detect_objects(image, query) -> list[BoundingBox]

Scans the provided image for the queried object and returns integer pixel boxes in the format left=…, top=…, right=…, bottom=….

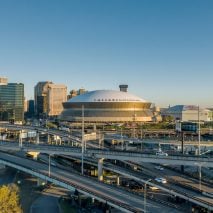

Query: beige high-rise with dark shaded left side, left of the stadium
left=35, top=81, right=67, bottom=117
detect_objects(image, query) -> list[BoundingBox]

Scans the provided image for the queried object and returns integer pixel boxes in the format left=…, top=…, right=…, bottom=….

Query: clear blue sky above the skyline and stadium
left=0, top=0, right=213, bottom=107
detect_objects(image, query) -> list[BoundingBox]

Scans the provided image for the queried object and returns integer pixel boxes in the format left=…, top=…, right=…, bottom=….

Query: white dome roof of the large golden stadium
left=68, top=90, right=147, bottom=103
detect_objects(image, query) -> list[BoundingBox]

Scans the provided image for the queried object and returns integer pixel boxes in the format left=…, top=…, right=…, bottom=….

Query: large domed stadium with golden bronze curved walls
left=59, top=90, right=152, bottom=123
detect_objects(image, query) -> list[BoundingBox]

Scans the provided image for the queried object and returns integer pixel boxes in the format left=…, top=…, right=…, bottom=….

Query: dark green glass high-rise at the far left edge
left=0, top=78, right=24, bottom=123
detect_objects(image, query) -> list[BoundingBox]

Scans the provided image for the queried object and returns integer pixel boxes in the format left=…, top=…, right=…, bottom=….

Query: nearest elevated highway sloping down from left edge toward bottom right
left=0, top=152, right=181, bottom=213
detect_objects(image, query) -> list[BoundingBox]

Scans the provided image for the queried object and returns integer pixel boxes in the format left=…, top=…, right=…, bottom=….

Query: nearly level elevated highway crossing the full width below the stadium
left=0, top=142, right=213, bottom=167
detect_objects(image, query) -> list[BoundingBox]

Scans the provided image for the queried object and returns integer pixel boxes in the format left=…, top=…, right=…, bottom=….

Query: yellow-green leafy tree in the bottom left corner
left=0, top=184, right=23, bottom=213
